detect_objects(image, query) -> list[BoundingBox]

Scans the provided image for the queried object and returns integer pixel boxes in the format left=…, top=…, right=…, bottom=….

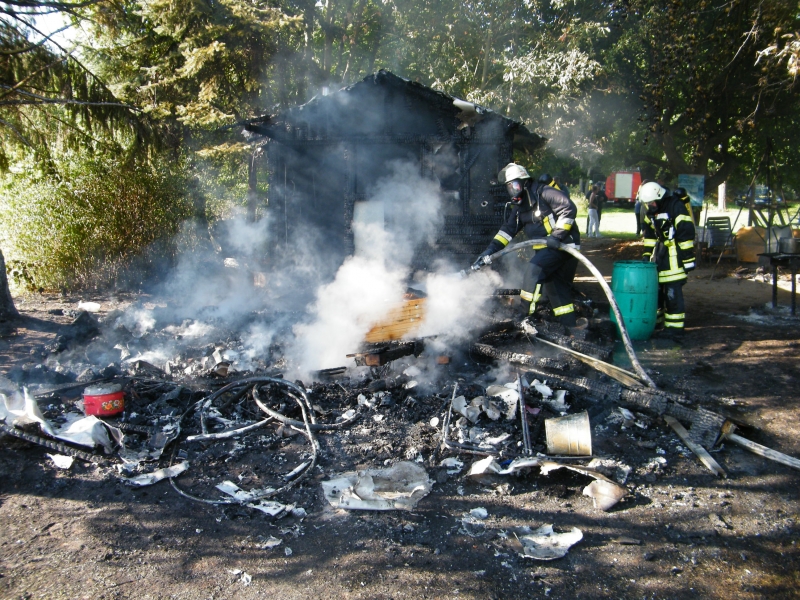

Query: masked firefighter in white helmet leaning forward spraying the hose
left=474, top=163, right=580, bottom=327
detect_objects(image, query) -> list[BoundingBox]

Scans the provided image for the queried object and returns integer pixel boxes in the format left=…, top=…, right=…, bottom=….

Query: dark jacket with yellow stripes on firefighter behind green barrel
left=642, top=195, right=695, bottom=283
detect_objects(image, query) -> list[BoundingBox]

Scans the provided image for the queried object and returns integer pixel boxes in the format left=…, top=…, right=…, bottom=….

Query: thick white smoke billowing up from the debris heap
left=104, top=162, right=506, bottom=379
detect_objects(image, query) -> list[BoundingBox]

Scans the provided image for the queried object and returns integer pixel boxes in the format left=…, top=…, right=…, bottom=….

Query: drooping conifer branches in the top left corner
left=0, top=0, right=156, bottom=170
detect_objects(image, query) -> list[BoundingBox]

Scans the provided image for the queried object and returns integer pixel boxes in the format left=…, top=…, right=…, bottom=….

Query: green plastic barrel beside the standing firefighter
left=611, top=260, right=658, bottom=340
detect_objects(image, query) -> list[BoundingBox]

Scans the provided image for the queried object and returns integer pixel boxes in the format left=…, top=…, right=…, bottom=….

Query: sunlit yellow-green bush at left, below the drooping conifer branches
left=0, top=154, right=192, bottom=289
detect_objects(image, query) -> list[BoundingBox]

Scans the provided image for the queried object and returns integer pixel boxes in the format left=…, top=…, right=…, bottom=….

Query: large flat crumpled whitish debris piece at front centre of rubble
left=322, top=461, right=432, bottom=510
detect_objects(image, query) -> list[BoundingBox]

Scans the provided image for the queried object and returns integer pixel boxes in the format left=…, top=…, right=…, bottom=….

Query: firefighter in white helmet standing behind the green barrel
left=638, top=181, right=695, bottom=338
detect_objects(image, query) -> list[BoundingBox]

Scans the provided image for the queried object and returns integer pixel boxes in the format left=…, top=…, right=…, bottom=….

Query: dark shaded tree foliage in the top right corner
left=605, top=0, right=798, bottom=188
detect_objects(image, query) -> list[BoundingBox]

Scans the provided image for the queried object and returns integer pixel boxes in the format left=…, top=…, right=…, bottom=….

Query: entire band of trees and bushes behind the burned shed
left=0, top=0, right=800, bottom=298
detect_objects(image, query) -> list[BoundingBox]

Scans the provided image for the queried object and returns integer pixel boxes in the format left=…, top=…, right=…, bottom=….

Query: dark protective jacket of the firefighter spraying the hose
left=487, top=181, right=581, bottom=254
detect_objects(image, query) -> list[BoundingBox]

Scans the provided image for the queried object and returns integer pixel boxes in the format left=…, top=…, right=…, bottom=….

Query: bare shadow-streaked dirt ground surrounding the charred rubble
left=0, top=239, right=800, bottom=600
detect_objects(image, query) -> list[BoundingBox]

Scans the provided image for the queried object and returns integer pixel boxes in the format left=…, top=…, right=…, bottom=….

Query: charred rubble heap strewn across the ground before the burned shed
left=0, top=286, right=791, bottom=580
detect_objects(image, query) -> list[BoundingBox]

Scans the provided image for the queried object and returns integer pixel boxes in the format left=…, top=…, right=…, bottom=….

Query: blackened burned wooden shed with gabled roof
left=246, top=70, right=544, bottom=269
